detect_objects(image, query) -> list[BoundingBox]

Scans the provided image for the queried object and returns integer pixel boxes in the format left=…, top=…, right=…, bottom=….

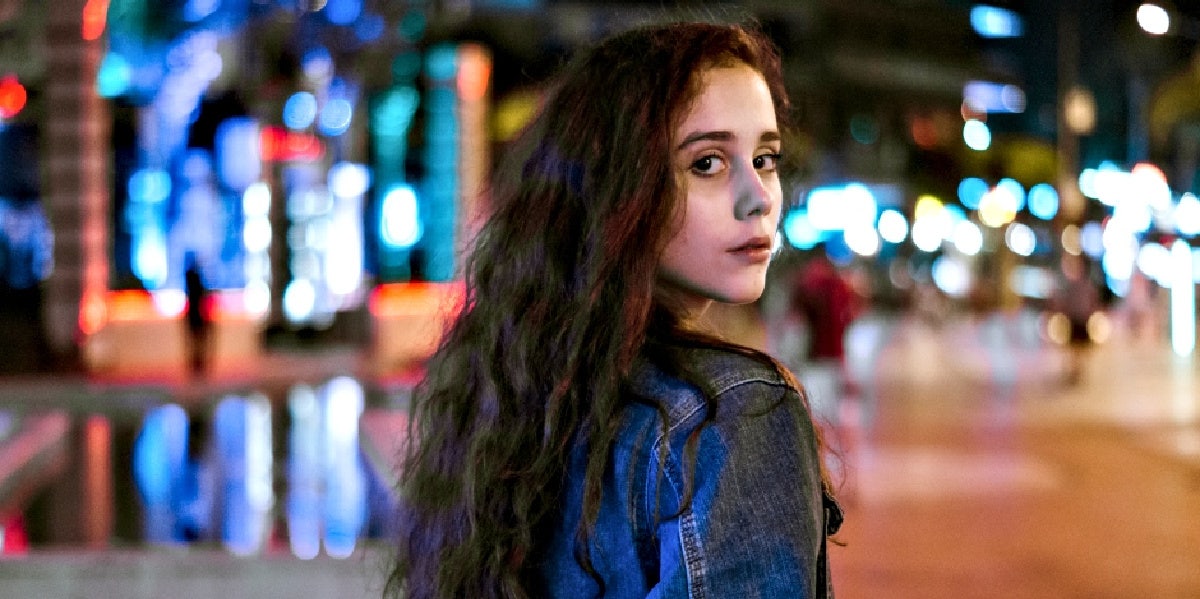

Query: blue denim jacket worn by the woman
left=538, top=348, right=841, bottom=599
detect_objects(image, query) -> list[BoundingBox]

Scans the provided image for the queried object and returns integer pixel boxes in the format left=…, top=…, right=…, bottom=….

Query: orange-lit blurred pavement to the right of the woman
left=830, top=312, right=1200, bottom=599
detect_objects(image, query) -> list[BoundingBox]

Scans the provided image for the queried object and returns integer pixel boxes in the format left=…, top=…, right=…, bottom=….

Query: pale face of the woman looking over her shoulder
left=658, top=65, right=782, bottom=312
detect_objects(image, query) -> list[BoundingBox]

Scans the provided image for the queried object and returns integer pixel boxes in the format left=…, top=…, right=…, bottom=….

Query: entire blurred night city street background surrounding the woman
left=0, top=0, right=1200, bottom=599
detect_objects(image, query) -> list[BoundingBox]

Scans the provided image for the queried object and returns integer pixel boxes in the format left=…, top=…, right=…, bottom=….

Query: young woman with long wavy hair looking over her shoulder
left=389, top=23, right=840, bottom=599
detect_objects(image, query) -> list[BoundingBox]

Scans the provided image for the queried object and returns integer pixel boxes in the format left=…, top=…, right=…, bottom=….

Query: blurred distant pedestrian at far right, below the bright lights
left=1052, top=253, right=1100, bottom=385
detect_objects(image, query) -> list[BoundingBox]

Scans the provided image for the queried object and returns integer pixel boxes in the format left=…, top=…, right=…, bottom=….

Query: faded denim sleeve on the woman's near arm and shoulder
left=647, top=382, right=829, bottom=598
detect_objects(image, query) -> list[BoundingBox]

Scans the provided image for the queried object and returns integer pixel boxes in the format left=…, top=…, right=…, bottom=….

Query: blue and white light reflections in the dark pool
left=133, top=377, right=386, bottom=559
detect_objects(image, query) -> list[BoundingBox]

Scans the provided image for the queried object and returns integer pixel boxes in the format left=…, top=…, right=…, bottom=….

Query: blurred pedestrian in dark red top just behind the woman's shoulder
left=792, top=245, right=862, bottom=423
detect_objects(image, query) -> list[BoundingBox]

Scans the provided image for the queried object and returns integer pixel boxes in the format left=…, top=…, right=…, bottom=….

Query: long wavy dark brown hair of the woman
left=388, top=18, right=825, bottom=599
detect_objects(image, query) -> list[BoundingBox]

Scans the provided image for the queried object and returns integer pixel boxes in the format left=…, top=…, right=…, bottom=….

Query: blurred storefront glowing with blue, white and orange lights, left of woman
left=0, top=0, right=491, bottom=372
